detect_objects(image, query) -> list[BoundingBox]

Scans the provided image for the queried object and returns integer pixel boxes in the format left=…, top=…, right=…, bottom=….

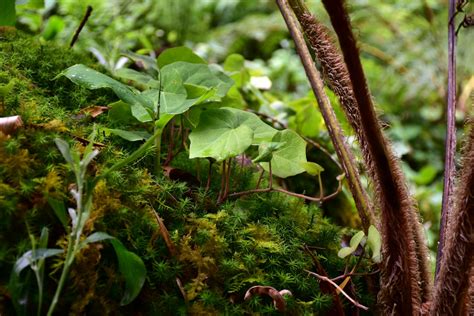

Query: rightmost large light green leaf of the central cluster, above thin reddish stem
left=259, top=130, right=307, bottom=178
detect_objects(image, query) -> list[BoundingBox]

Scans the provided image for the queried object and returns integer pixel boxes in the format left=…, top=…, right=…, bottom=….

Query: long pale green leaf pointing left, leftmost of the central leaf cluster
left=56, top=64, right=152, bottom=122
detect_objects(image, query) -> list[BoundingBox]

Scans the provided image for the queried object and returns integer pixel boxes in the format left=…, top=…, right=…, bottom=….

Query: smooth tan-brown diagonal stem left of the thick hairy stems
left=277, top=0, right=375, bottom=233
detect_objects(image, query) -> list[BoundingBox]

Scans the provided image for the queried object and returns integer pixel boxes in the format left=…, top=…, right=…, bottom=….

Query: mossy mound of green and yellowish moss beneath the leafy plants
left=0, top=29, right=373, bottom=315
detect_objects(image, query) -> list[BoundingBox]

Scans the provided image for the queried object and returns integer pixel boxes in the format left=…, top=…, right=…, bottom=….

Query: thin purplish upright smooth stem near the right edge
left=435, top=0, right=456, bottom=283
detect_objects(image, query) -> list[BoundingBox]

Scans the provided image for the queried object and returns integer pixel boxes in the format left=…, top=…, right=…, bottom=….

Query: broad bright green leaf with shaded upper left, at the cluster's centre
left=189, top=109, right=253, bottom=161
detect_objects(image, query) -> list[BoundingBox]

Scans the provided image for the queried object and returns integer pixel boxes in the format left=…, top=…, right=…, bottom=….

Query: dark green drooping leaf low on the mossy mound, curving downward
left=110, top=239, right=146, bottom=306
